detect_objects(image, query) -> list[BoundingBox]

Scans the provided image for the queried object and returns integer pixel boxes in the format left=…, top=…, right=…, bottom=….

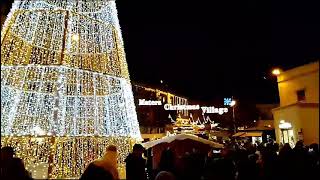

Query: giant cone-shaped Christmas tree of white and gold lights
left=1, top=0, right=141, bottom=178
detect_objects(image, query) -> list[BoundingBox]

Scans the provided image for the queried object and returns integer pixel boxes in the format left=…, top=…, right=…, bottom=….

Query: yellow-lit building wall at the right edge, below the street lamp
left=273, top=62, right=319, bottom=144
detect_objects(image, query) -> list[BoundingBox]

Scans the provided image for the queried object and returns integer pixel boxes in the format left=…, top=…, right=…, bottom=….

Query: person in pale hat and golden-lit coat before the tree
left=80, top=145, right=119, bottom=180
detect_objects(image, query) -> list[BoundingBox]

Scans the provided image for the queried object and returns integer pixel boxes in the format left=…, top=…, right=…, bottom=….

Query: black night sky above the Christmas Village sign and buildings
left=117, top=0, right=320, bottom=103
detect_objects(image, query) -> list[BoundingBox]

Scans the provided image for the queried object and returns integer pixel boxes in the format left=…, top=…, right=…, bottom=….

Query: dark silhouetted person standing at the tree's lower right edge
left=125, top=144, right=147, bottom=180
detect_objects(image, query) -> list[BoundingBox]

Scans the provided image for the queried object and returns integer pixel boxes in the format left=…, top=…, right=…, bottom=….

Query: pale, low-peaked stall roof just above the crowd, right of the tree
left=142, top=134, right=223, bottom=149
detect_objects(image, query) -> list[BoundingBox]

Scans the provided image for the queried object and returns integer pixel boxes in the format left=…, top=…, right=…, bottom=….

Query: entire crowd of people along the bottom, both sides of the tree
left=1, top=141, right=319, bottom=180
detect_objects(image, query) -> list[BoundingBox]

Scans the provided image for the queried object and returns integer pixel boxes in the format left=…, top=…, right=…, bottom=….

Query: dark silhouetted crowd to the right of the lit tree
left=127, top=141, right=320, bottom=180
